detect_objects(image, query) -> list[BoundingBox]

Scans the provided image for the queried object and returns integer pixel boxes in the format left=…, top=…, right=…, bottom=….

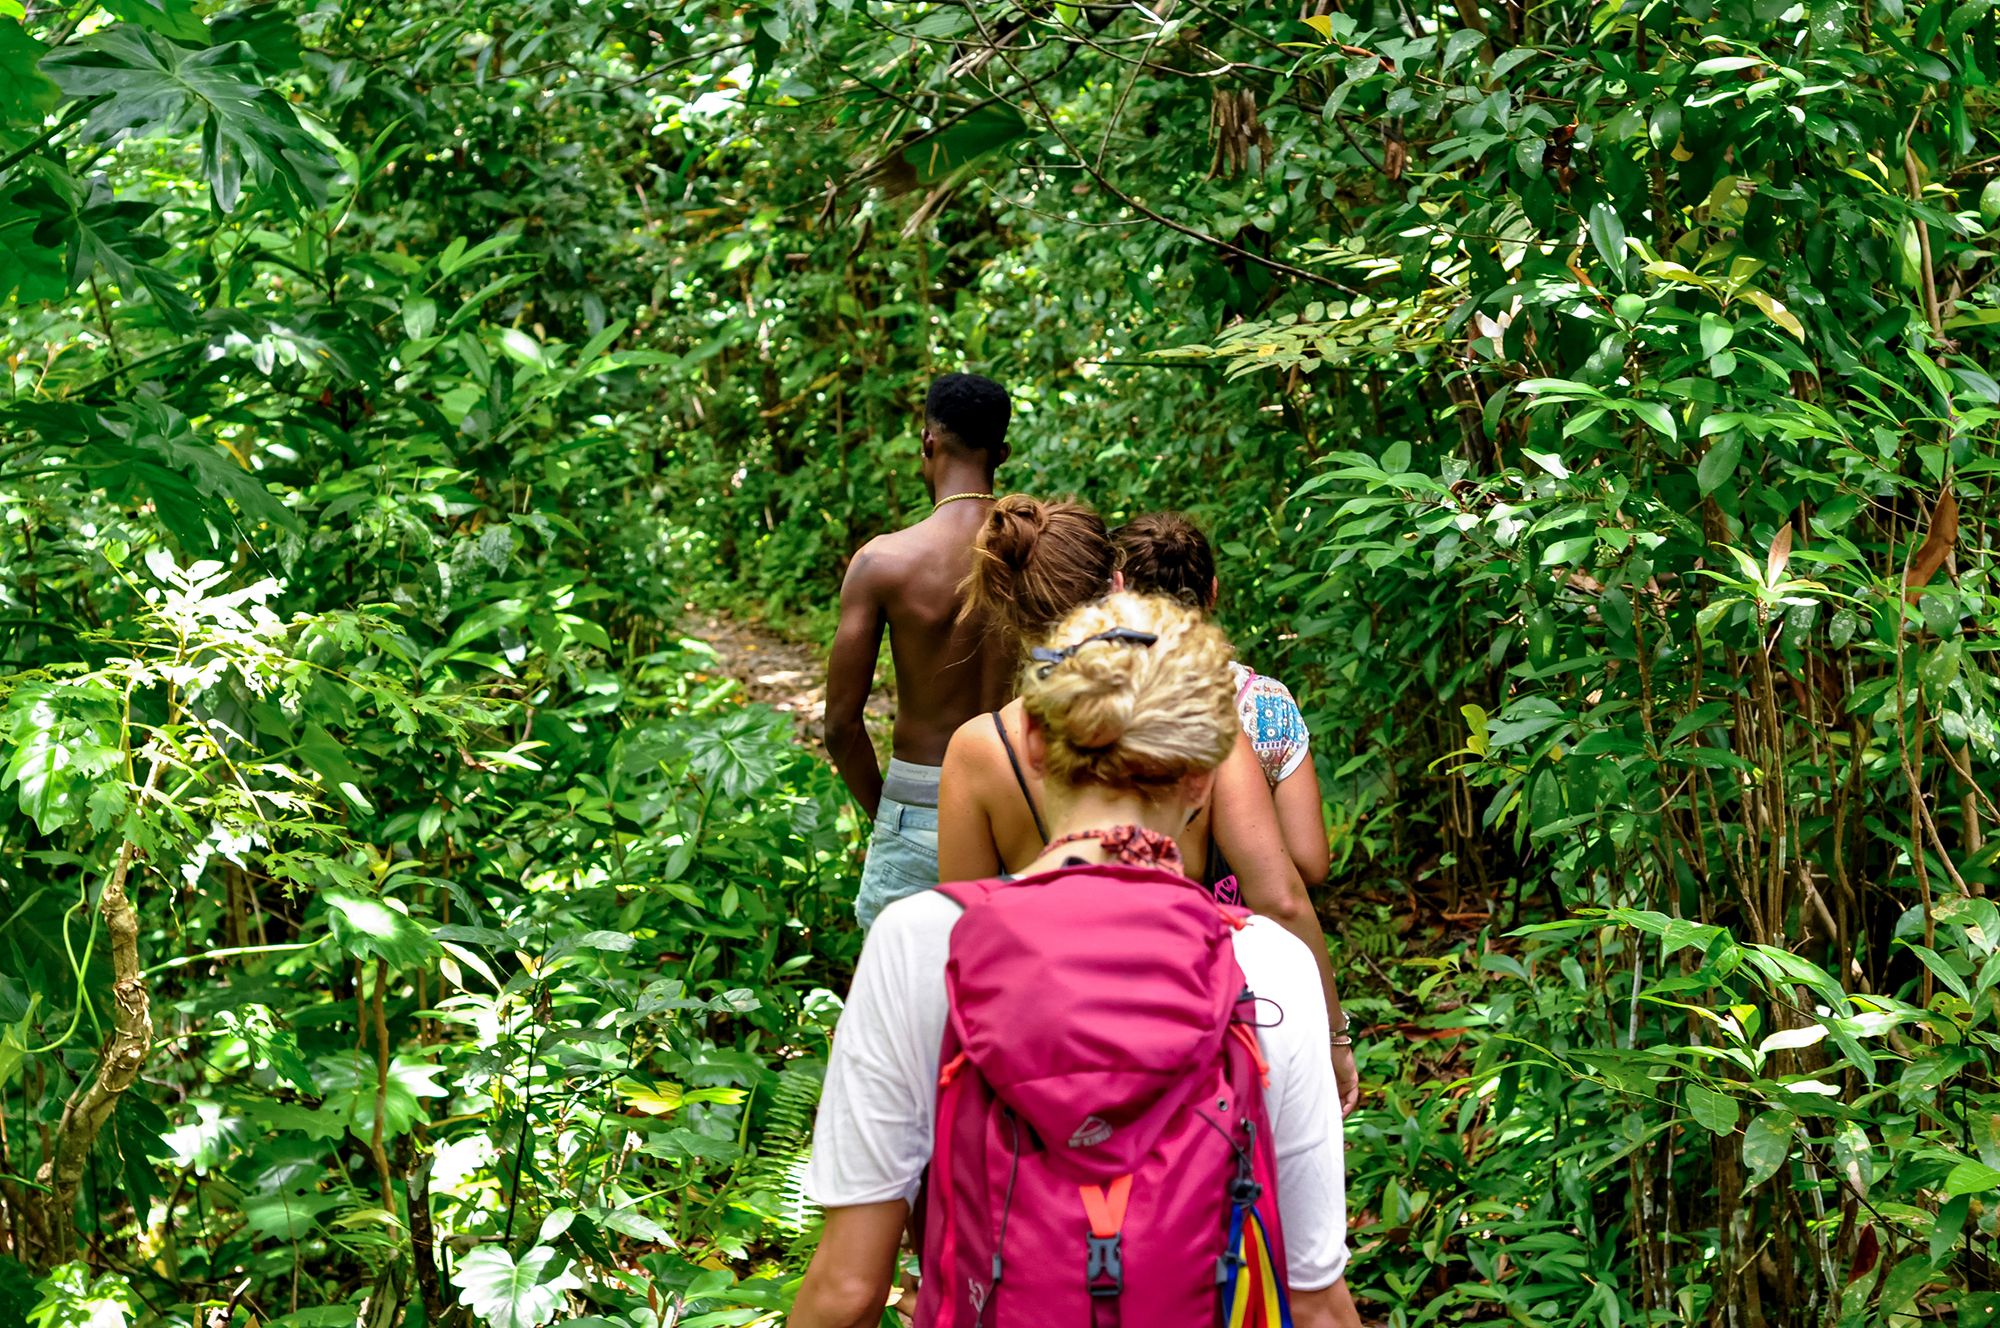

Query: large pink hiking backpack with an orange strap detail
left=916, top=866, right=1292, bottom=1328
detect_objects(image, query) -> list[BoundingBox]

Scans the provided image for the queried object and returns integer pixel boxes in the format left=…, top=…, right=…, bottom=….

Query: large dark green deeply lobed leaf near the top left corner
left=42, top=24, right=334, bottom=212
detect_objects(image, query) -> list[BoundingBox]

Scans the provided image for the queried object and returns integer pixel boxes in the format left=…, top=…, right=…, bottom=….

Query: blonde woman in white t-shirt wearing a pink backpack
left=790, top=592, right=1358, bottom=1328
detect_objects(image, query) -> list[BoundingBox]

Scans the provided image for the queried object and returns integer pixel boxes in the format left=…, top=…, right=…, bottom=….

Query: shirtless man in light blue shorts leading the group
left=826, top=374, right=1012, bottom=928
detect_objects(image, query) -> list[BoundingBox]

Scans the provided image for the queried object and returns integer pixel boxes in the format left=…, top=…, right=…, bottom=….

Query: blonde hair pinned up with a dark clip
left=1020, top=592, right=1238, bottom=788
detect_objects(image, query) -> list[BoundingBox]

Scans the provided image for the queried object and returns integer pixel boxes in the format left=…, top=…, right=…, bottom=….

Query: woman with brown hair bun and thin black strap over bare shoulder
left=938, top=494, right=1360, bottom=1112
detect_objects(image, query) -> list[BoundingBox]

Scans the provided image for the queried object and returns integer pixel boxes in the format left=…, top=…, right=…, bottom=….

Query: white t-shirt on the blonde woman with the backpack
left=806, top=890, right=1348, bottom=1290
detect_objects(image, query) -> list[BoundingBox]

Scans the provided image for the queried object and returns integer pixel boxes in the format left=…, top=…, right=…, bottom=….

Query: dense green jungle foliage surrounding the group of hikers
left=0, top=0, right=2000, bottom=1328
